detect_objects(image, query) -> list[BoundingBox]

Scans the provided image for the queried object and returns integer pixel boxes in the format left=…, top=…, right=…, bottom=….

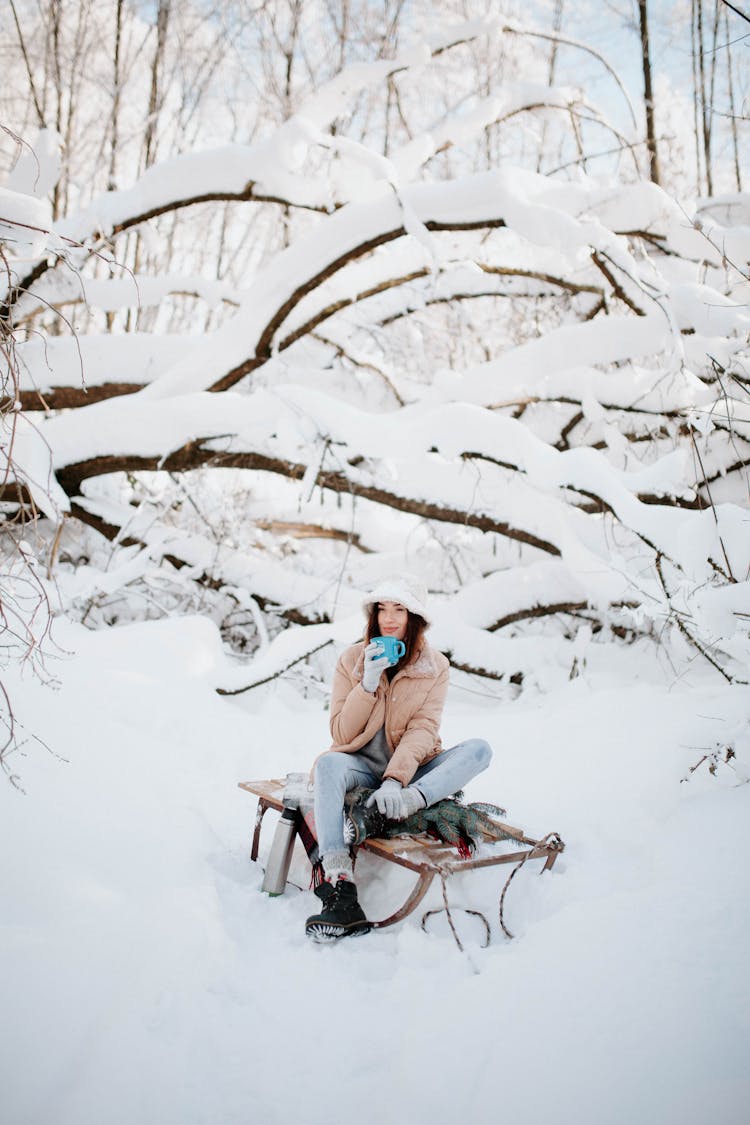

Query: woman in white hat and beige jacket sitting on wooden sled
left=306, top=575, right=493, bottom=941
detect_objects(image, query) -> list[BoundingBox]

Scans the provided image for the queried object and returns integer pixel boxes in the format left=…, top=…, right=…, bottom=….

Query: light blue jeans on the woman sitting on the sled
left=314, top=738, right=493, bottom=855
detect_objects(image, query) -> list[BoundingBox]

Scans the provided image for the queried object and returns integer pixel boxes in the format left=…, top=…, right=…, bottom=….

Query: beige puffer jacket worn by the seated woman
left=331, top=641, right=450, bottom=785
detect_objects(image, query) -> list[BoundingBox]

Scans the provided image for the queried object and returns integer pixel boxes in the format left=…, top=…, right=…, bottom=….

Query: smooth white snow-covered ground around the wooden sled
left=0, top=618, right=750, bottom=1125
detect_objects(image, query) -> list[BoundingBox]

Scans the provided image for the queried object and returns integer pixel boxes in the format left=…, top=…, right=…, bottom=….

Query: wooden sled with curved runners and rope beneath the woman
left=238, top=779, right=564, bottom=941
